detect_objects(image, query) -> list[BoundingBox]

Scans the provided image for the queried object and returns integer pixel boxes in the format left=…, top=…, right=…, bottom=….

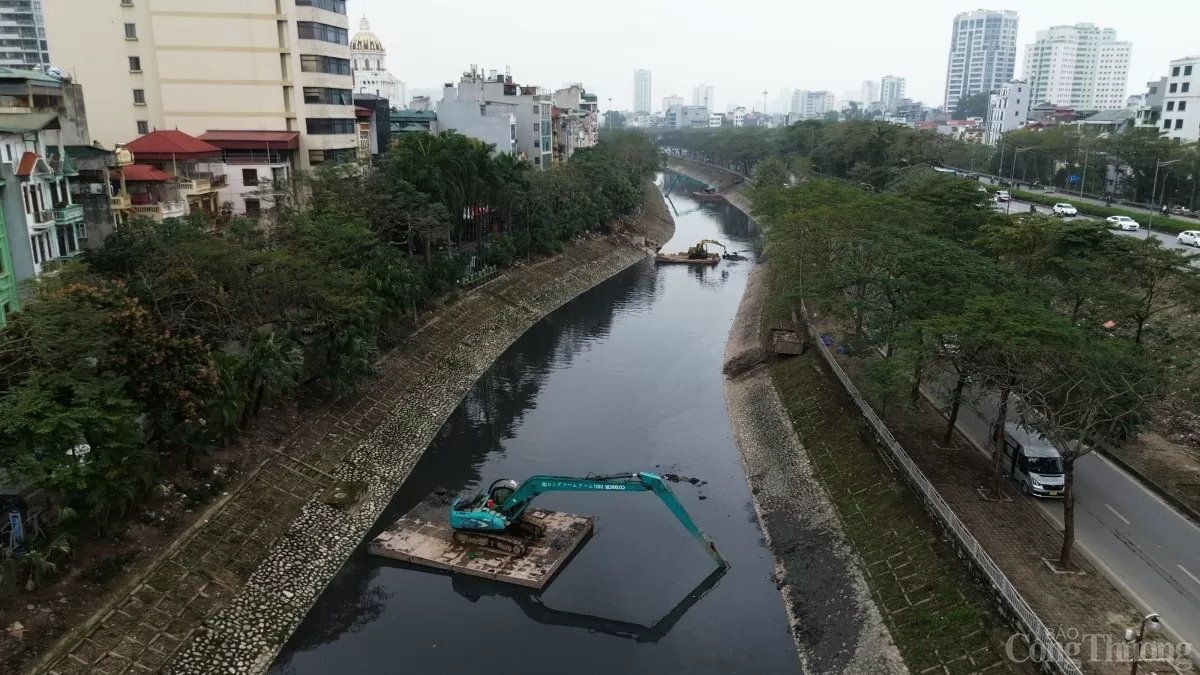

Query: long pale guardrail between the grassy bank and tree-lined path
left=793, top=303, right=1082, bottom=675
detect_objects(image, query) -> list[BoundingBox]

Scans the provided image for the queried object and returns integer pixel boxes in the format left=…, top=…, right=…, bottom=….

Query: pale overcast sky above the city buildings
left=348, top=0, right=1200, bottom=110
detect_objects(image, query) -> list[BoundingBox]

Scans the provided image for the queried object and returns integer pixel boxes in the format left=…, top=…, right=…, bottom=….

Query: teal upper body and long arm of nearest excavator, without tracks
left=450, top=471, right=730, bottom=568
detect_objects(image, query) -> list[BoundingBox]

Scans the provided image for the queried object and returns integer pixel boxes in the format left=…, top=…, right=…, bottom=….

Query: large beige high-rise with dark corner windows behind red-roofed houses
left=44, top=0, right=358, bottom=168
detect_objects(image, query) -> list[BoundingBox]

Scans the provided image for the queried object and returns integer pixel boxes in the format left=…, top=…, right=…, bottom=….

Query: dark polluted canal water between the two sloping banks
left=271, top=174, right=800, bottom=675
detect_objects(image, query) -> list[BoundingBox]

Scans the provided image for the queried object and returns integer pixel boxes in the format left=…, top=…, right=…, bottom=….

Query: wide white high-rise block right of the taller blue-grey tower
left=1025, top=23, right=1132, bottom=110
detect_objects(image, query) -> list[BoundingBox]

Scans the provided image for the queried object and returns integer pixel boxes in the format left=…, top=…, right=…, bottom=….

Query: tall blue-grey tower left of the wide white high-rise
left=946, top=10, right=1016, bottom=112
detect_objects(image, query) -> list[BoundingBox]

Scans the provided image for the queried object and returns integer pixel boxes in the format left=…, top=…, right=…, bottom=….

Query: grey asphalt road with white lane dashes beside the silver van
left=926, top=369, right=1200, bottom=664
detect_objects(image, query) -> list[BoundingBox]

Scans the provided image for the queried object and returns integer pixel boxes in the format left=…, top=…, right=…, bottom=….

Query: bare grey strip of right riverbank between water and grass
left=725, top=263, right=906, bottom=674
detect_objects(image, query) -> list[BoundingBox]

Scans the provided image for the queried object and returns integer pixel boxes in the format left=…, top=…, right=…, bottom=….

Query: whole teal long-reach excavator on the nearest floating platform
left=450, top=471, right=730, bottom=568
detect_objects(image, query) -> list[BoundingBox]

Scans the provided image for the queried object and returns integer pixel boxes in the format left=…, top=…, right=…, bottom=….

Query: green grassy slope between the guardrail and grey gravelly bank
left=768, top=355, right=1025, bottom=673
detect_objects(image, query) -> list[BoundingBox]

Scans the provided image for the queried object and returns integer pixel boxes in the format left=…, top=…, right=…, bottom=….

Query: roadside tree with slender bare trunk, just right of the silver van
left=1013, top=336, right=1163, bottom=567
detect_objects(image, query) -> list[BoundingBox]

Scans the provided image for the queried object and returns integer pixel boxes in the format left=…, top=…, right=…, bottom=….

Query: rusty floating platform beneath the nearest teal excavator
left=367, top=504, right=593, bottom=590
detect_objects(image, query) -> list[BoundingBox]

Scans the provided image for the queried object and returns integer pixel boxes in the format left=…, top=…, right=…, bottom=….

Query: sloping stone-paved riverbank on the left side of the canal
left=35, top=185, right=674, bottom=674
